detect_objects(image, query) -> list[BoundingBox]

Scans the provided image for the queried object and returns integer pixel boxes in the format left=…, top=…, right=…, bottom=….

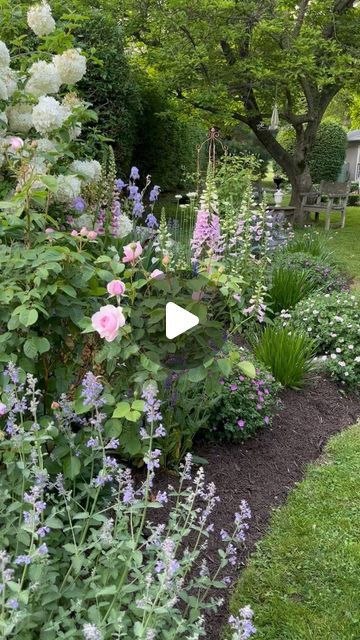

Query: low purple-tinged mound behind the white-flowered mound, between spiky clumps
left=273, top=250, right=347, bottom=292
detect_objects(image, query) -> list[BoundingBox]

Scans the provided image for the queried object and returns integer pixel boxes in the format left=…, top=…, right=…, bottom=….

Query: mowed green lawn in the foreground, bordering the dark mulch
left=225, top=425, right=360, bottom=640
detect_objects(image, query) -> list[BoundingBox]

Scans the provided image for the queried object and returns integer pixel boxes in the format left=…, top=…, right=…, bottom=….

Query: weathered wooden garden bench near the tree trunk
left=301, top=180, right=350, bottom=230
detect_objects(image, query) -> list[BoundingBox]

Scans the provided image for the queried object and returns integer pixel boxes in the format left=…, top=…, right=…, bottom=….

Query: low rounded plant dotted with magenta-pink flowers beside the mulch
left=202, top=345, right=280, bottom=442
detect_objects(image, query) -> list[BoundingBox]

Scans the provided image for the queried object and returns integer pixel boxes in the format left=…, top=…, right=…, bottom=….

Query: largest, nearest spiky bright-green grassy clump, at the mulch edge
left=254, top=325, right=316, bottom=389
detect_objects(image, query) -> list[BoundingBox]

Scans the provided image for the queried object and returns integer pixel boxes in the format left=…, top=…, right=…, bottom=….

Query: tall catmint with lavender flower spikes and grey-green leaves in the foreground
left=0, top=363, right=255, bottom=640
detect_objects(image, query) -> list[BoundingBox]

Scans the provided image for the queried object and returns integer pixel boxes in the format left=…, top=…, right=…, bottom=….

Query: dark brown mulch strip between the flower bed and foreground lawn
left=195, top=380, right=360, bottom=640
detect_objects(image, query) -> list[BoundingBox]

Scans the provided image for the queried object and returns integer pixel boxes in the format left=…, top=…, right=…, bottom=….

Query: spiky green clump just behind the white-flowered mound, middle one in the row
left=269, top=267, right=317, bottom=314
